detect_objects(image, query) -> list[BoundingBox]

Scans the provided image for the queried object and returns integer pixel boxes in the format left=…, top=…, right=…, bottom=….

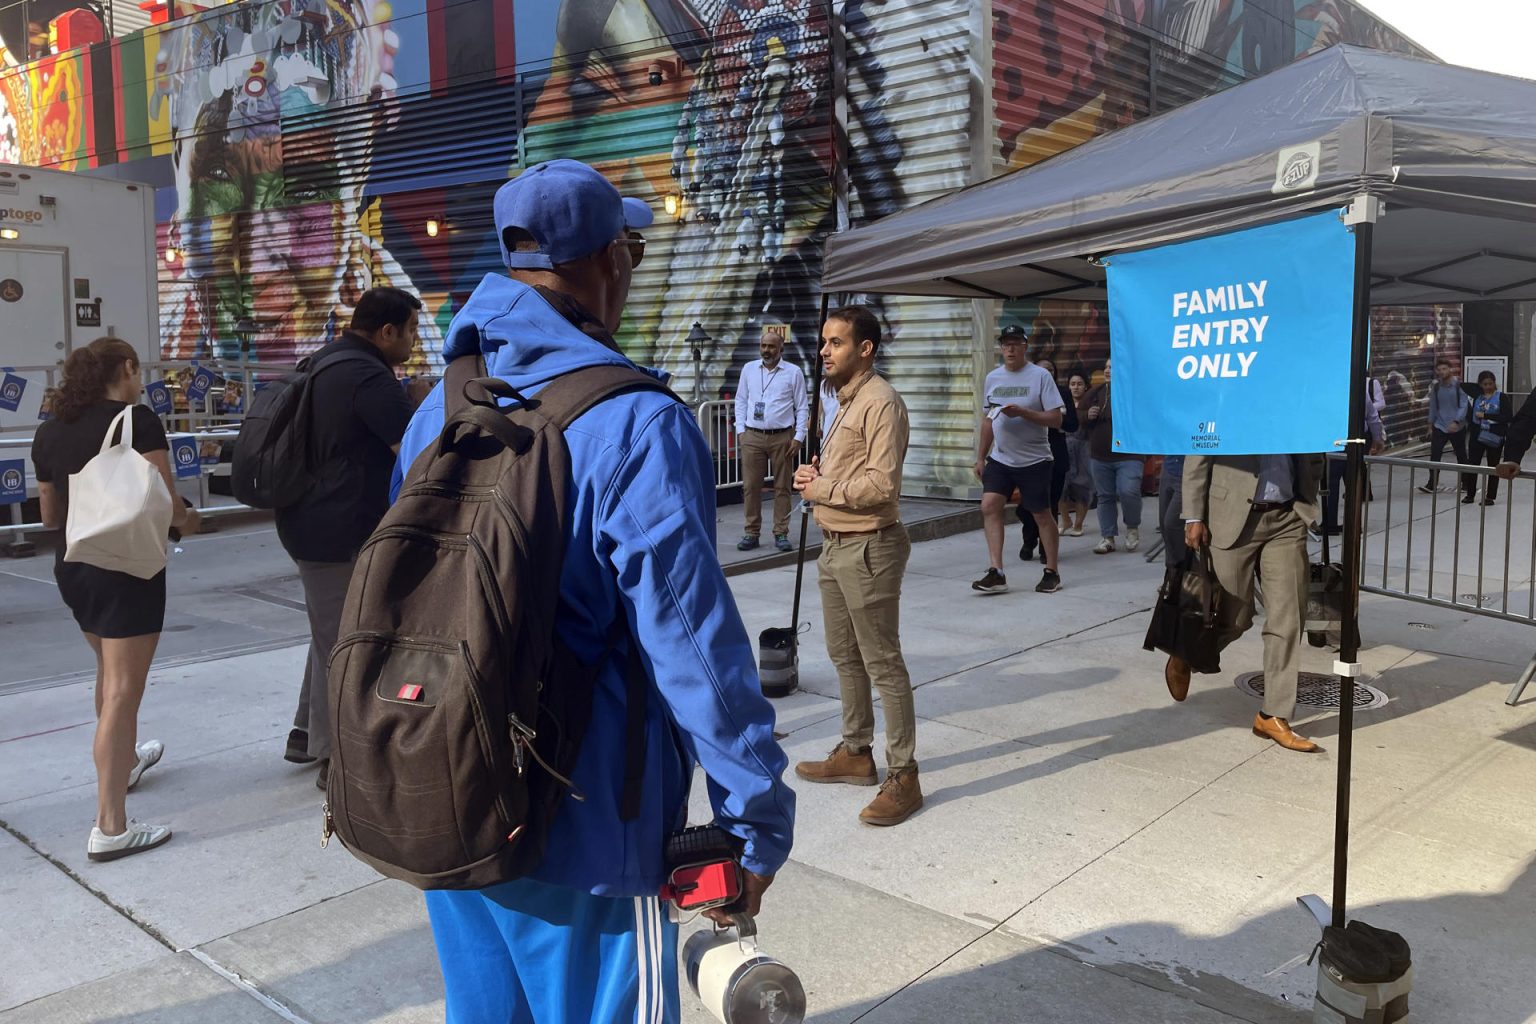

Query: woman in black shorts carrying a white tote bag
left=32, top=338, right=198, bottom=861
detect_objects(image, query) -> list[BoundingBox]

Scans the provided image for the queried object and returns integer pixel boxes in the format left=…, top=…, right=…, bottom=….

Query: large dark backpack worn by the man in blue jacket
left=324, top=356, right=670, bottom=889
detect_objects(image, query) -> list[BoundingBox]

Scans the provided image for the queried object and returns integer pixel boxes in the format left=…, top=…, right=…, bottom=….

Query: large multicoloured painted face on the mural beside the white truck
left=163, top=0, right=430, bottom=366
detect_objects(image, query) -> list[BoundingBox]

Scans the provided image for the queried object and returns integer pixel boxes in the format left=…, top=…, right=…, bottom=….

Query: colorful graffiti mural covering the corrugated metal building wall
left=0, top=0, right=1431, bottom=493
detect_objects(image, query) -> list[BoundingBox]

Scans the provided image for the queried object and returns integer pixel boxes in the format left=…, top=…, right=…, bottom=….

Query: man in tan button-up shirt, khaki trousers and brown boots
left=794, top=306, right=923, bottom=824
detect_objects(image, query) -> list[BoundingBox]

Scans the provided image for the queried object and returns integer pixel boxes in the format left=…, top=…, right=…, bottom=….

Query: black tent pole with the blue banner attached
left=1333, top=208, right=1376, bottom=927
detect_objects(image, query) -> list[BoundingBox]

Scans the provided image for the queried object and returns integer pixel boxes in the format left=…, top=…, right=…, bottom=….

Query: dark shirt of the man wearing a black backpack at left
left=278, top=333, right=412, bottom=562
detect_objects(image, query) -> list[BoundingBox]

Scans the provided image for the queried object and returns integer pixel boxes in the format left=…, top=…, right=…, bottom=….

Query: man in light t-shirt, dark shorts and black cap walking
left=971, top=324, right=1066, bottom=594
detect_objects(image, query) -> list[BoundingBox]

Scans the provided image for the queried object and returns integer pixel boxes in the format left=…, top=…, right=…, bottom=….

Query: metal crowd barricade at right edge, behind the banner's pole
left=1333, top=456, right=1536, bottom=705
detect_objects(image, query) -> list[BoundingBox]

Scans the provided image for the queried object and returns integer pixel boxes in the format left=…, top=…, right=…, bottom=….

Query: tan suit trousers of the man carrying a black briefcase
left=1210, top=508, right=1307, bottom=718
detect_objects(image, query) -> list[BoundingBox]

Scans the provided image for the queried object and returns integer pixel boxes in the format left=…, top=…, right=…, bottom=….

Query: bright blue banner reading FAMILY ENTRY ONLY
left=1107, top=210, right=1355, bottom=454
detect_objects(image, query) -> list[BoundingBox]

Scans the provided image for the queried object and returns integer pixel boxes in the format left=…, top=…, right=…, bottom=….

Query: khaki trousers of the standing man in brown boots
left=817, top=524, right=917, bottom=771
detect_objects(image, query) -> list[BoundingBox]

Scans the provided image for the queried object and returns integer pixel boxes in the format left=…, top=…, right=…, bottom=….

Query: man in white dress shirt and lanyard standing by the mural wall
left=736, top=327, right=811, bottom=551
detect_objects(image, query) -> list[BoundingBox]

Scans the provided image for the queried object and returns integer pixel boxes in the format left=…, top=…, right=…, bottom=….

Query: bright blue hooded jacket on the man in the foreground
left=390, top=275, right=794, bottom=897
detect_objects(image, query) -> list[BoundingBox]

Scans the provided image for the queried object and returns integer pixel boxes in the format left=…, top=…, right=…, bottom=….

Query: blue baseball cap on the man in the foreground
left=493, top=160, right=654, bottom=270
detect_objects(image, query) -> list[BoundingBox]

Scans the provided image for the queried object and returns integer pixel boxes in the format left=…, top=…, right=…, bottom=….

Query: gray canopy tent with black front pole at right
left=823, top=46, right=1536, bottom=927
